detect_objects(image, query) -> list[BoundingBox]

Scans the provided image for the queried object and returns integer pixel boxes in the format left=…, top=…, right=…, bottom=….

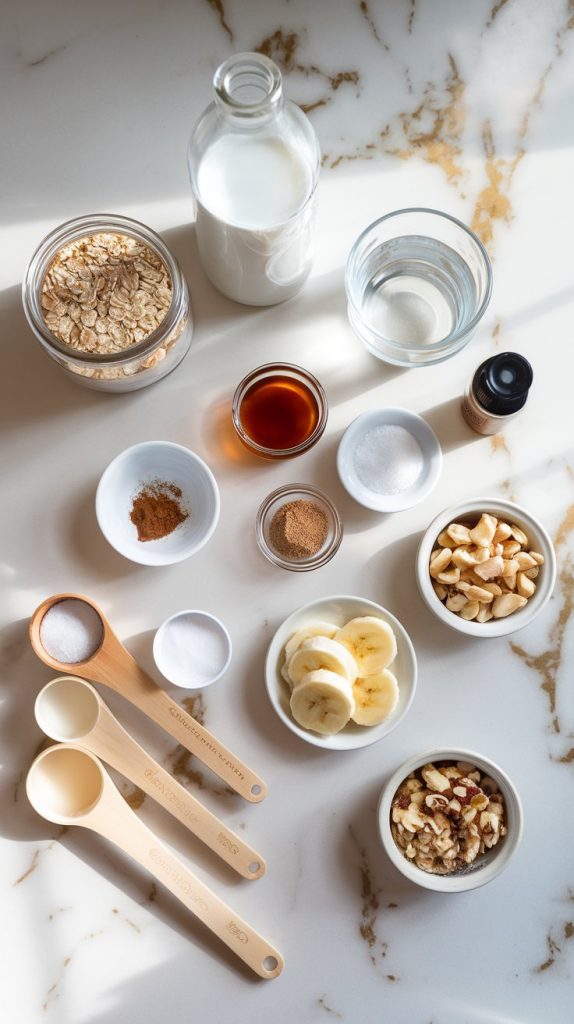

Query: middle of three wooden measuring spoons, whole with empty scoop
left=34, top=676, right=265, bottom=880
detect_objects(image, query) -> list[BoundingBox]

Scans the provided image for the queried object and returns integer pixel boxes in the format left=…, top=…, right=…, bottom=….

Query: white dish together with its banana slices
left=265, top=595, right=416, bottom=751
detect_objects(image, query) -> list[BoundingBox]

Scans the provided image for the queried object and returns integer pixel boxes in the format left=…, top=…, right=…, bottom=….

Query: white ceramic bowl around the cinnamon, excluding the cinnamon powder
left=95, top=441, right=219, bottom=565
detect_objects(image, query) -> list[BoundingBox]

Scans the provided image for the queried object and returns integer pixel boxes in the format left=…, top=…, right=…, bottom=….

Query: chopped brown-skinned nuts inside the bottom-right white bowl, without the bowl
left=391, top=761, right=506, bottom=874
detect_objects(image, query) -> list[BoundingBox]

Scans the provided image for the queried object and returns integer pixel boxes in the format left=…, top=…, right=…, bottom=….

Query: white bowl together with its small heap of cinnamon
left=95, top=441, right=219, bottom=565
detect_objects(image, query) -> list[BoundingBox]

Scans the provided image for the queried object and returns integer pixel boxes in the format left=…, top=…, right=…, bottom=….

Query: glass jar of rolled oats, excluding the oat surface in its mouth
left=23, top=213, right=193, bottom=392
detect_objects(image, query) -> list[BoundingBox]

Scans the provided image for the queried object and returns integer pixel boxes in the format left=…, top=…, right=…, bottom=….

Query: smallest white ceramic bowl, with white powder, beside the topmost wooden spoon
left=153, top=608, right=231, bottom=690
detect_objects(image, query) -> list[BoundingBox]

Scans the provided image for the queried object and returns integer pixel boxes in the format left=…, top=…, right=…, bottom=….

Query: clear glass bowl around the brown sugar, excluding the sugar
left=255, top=483, right=343, bottom=572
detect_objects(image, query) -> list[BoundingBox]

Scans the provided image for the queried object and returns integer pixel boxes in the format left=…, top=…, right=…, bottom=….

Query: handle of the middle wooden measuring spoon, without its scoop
left=86, top=701, right=265, bottom=880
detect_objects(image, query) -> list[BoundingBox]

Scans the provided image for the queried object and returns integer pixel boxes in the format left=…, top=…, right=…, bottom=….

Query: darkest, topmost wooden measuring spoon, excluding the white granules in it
left=30, top=594, right=267, bottom=804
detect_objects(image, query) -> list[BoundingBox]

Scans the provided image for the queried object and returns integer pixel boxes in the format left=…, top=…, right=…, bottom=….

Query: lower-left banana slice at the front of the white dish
left=291, top=669, right=355, bottom=736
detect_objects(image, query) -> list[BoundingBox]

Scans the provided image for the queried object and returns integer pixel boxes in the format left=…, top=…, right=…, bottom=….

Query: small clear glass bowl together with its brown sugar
left=256, top=483, right=343, bottom=572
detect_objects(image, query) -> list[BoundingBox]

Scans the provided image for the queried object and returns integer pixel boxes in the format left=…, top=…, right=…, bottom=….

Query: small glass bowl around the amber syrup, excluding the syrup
left=231, top=362, right=328, bottom=459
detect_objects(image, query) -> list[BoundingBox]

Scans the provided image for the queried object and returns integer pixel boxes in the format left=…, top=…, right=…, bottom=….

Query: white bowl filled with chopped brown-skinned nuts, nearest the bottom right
left=379, top=748, right=523, bottom=893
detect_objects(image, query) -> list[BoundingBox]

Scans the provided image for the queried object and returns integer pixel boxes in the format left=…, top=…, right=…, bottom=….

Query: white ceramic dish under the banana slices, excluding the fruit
left=265, top=594, right=416, bottom=751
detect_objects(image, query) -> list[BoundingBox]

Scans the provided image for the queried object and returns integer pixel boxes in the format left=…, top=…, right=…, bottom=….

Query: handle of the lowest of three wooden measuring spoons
left=90, top=798, right=283, bottom=979
